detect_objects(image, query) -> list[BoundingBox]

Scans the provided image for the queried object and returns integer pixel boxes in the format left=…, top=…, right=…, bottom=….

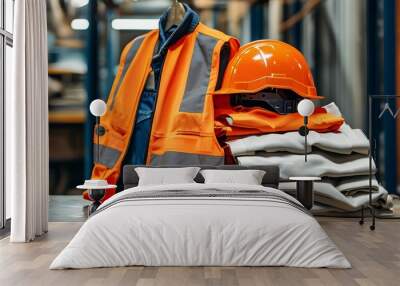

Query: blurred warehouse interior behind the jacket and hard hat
left=47, top=0, right=400, bottom=202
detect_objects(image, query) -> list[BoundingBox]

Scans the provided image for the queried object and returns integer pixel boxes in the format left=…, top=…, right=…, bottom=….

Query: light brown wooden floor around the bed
left=0, top=218, right=400, bottom=286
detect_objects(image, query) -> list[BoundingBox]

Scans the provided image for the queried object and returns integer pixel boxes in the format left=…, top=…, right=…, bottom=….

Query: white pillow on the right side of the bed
left=200, top=169, right=265, bottom=185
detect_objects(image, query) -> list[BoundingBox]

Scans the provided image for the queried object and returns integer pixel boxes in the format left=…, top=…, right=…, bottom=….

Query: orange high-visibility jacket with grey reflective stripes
left=92, top=23, right=239, bottom=187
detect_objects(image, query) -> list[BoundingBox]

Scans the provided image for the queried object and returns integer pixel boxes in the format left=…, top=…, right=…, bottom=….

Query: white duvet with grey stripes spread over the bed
left=50, top=184, right=350, bottom=269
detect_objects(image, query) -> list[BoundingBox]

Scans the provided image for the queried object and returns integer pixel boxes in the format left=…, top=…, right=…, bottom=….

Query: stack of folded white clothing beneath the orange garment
left=227, top=104, right=387, bottom=211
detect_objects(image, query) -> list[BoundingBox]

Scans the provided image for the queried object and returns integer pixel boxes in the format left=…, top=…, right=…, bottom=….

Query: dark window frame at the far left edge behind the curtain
left=0, top=0, right=15, bottom=230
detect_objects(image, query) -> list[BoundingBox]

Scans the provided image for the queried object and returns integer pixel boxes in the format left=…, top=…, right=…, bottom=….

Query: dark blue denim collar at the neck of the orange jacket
left=159, top=3, right=200, bottom=51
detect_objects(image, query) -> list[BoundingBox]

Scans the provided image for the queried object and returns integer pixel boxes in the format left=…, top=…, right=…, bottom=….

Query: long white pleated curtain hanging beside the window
left=6, top=0, right=49, bottom=242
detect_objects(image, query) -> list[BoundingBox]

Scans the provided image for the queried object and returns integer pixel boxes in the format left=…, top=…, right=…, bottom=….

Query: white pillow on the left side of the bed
left=135, top=167, right=200, bottom=186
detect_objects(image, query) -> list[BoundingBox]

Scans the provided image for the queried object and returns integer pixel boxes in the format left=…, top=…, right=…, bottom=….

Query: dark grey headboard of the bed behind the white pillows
left=122, top=165, right=279, bottom=190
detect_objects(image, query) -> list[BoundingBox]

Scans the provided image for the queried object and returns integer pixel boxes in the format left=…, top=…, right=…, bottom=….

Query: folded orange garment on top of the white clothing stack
left=215, top=106, right=344, bottom=138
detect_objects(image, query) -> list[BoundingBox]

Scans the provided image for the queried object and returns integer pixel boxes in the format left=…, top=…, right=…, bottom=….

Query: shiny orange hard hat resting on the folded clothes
left=215, top=40, right=322, bottom=99
